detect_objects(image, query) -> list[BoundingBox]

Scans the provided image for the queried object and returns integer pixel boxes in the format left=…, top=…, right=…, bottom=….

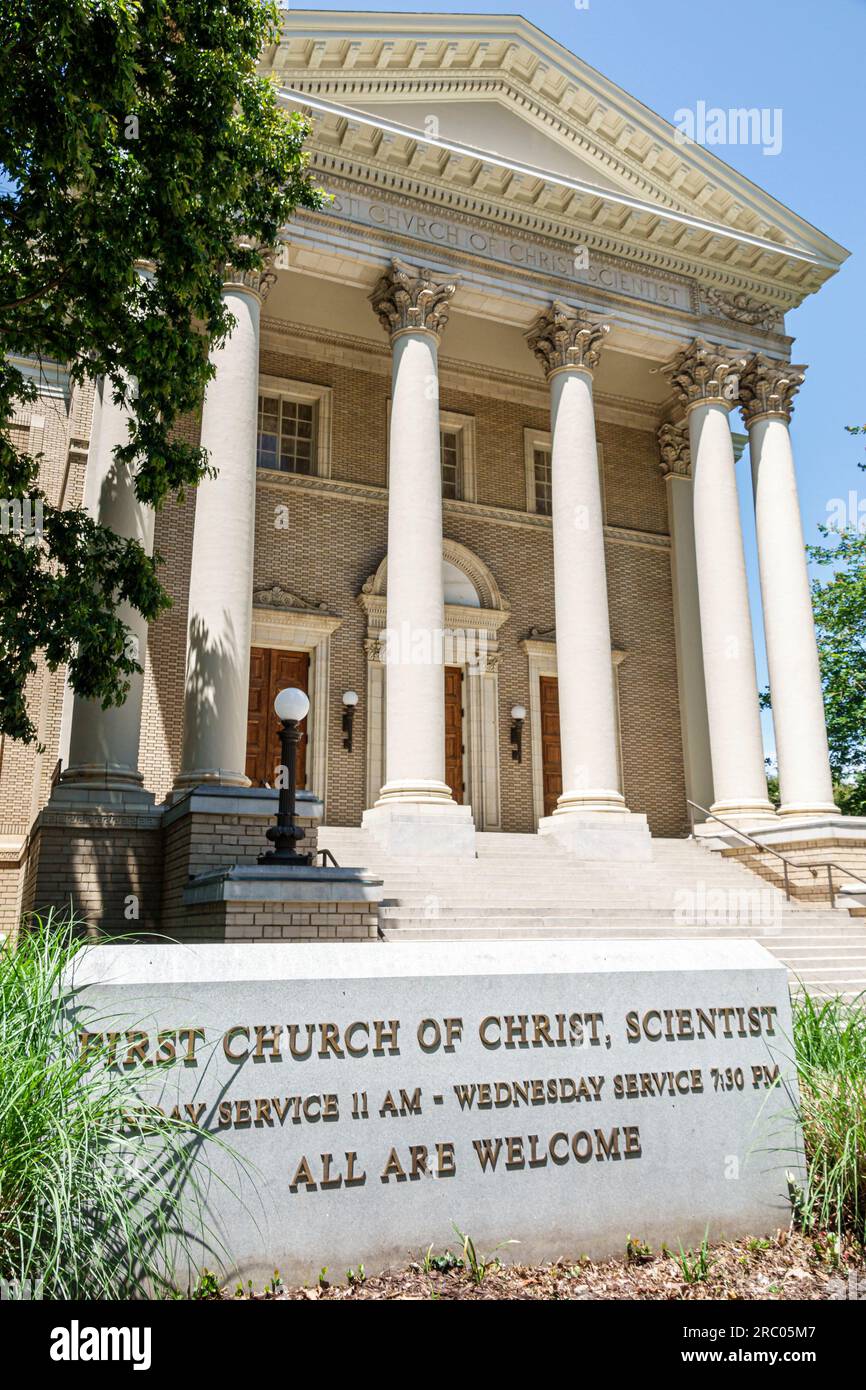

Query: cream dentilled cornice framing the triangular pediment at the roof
left=263, top=10, right=847, bottom=307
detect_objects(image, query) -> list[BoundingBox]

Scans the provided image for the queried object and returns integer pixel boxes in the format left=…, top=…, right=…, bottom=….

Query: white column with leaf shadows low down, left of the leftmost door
left=175, top=255, right=275, bottom=790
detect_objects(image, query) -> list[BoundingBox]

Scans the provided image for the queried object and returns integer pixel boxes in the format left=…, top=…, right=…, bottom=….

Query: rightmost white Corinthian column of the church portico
left=740, top=353, right=838, bottom=816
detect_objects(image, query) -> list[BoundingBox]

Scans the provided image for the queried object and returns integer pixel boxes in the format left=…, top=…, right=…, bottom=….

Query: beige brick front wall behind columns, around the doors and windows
left=244, top=352, right=687, bottom=835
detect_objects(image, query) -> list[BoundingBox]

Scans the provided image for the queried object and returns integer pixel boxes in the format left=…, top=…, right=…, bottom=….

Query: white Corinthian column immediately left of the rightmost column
left=664, top=339, right=774, bottom=828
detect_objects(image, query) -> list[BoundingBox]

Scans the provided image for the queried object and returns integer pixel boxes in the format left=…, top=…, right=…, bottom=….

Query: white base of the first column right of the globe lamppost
left=361, top=800, right=475, bottom=859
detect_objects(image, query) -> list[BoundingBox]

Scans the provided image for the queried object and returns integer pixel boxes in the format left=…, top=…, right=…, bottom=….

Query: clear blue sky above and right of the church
left=307, top=0, right=866, bottom=752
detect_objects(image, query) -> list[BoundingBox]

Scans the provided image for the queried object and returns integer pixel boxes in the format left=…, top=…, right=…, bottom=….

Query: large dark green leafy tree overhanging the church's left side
left=0, top=0, right=324, bottom=739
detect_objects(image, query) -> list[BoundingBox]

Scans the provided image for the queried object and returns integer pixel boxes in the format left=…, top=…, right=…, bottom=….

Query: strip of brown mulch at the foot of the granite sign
left=221, top=1232, right=866, bottom=1301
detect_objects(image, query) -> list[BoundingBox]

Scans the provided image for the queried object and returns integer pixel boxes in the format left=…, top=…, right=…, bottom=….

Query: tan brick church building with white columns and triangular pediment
left=0, top=10, right=862, bottom=929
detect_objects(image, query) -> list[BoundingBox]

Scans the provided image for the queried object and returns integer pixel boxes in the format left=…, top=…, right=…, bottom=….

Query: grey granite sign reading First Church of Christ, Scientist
left=69, top=941, right=802, bottom=1280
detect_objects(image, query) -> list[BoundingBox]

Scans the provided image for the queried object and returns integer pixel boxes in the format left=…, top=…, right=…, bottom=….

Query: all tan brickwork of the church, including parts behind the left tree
left=0, top=334, right=687, bottom=924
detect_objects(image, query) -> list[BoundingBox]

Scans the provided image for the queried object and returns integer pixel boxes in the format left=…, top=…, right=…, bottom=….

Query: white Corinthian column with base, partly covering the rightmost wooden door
left=527, top=302, right=651, bottom=858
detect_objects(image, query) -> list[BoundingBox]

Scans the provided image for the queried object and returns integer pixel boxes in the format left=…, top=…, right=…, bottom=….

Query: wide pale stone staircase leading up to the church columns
left=318, top=826, right=866, bottom=998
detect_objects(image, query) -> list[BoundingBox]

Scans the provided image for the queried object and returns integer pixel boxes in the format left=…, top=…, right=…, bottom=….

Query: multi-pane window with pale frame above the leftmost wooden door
left=256, top=377, right=331, bottom=477
